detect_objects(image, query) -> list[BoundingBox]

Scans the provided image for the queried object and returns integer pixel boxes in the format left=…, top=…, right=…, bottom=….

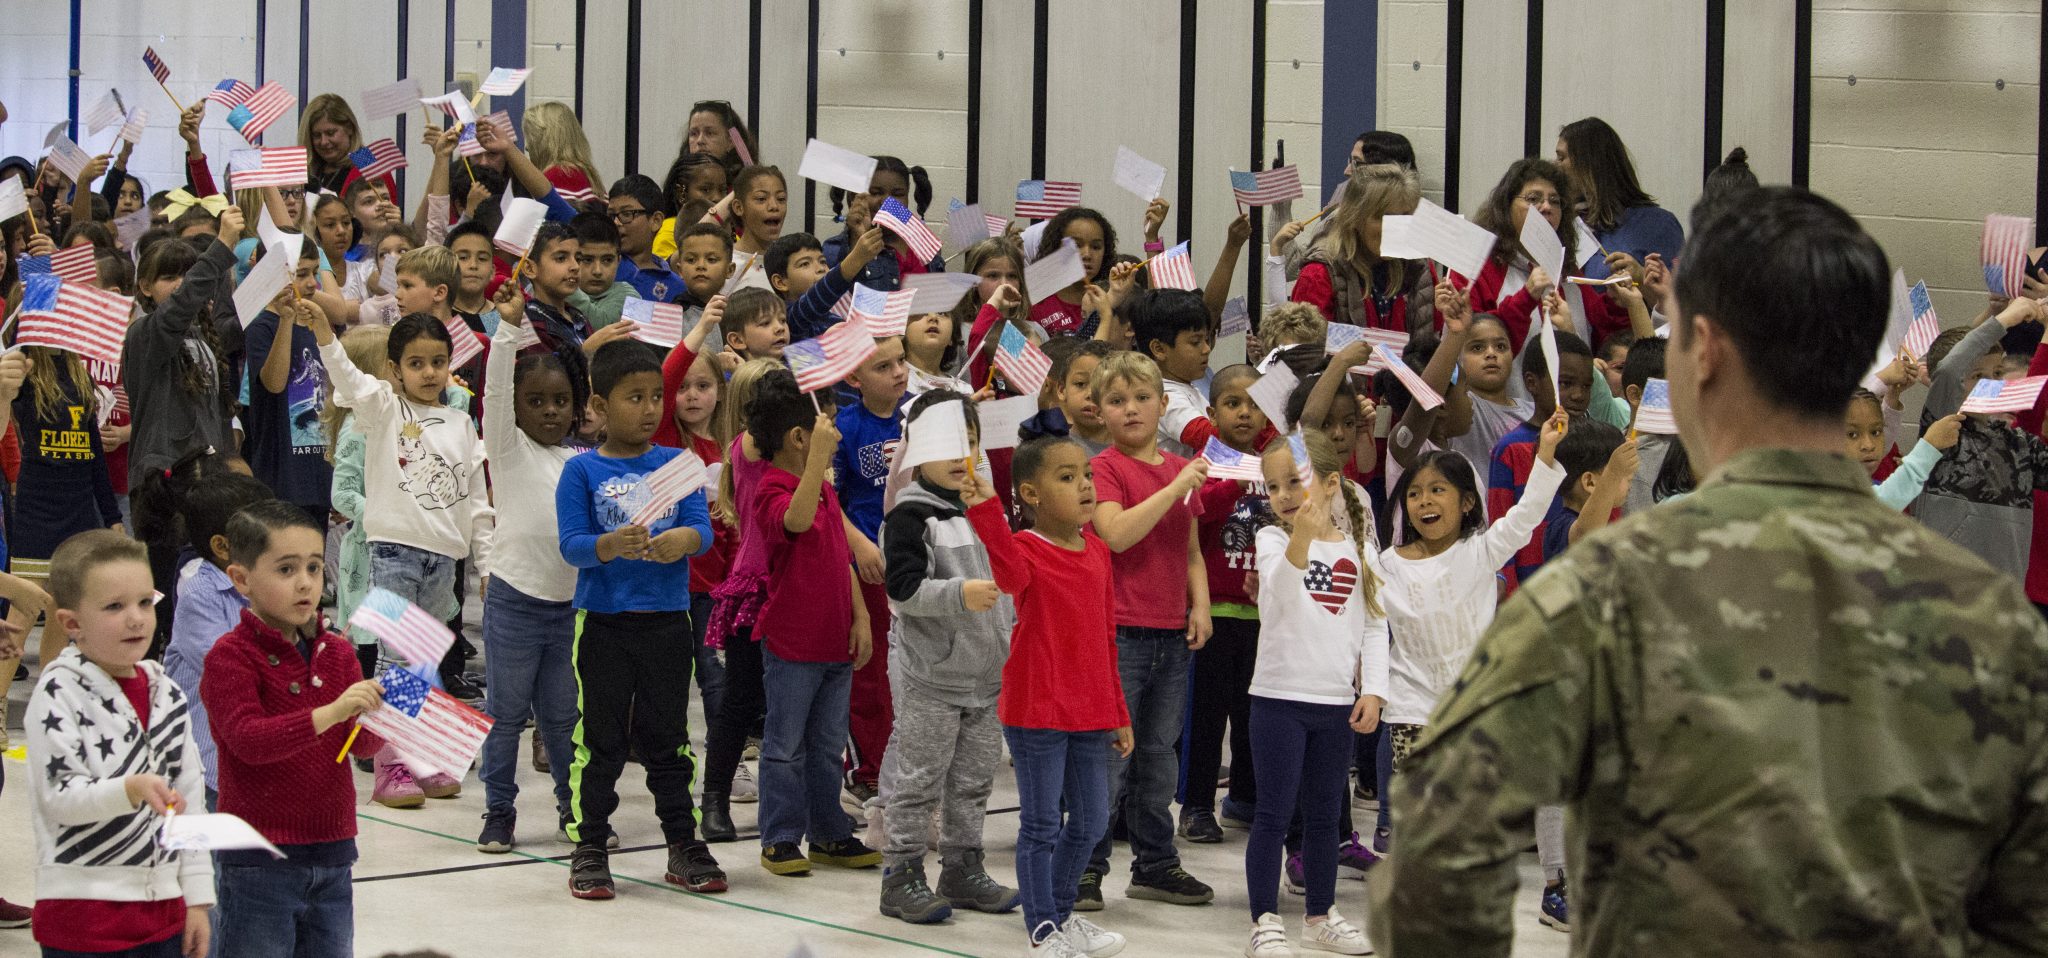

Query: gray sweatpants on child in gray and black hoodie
left=879, top=682, right=1004, bottom=868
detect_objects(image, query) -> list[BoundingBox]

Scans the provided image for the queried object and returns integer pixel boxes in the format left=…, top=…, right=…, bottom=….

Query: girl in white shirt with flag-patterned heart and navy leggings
left=1231, top=430, right=1386, bottom=958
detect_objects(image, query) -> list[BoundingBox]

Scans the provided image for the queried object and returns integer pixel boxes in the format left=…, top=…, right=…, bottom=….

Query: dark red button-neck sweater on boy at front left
left=199, top=610, right=383, bottom=845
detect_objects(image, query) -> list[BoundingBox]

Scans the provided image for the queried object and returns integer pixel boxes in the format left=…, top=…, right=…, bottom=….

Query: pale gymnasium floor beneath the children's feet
left=0, top=604, right=1567, bottom=958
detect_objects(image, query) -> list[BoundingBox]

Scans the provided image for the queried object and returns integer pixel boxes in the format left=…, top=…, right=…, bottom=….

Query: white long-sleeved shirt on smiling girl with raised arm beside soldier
left=1376, top=459, right=1565, bottom=725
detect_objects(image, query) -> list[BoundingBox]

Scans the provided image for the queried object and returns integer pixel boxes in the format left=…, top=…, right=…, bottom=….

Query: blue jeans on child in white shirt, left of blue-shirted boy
left=477, top=579, right=578, bottom=815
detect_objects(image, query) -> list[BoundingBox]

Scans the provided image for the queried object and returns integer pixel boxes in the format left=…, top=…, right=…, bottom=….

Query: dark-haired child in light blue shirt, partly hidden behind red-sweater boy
left=164, top=475, right=270, bottom=811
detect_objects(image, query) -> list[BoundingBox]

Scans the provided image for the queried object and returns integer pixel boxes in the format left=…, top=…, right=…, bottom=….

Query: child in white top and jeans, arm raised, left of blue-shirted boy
left=477, top=282, right=585, bottom=854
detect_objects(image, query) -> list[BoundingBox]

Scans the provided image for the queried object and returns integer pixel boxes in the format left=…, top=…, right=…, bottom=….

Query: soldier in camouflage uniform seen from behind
left=1372, top=188, right=2048, bottom=958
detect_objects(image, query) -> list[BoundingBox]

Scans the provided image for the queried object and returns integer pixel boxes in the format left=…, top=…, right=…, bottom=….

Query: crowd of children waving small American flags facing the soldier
left=0, top=82, right=2048, bottom=958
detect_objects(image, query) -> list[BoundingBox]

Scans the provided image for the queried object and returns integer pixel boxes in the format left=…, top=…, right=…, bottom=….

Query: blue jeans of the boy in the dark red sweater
left=213, top=862, right=356, bottom=958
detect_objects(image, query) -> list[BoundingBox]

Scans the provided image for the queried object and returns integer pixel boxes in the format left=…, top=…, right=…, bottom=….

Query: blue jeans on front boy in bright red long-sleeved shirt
left=1004, top=725, right=1110, bottom=933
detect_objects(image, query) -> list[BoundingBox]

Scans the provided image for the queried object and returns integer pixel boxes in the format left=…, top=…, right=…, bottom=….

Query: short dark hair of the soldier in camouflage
left=1675, top=186, right=1892, bottom=420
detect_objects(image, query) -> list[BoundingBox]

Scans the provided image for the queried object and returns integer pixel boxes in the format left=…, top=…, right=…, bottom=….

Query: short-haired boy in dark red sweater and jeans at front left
left=199, top=499, right=383, bottom=958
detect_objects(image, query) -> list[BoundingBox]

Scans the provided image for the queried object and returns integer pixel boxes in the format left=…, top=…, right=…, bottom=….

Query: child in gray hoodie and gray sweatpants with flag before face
left=881, top=389, right=1018, bottom=923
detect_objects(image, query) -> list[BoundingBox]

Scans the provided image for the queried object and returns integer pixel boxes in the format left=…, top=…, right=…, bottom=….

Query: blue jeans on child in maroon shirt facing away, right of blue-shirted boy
left=760, top=643, right=854, bottom=847
